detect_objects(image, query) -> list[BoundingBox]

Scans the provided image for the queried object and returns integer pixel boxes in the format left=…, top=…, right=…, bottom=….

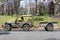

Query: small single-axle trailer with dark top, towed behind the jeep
left=39, top=22, right=57, bottom=31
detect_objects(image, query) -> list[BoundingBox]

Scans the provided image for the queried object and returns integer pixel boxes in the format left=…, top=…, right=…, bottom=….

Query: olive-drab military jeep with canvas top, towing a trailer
left=2, top=15, right=33, bottom=31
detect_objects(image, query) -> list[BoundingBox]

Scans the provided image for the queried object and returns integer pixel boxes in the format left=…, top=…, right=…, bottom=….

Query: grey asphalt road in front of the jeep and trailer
left=0, top=30, right=60, bottom=40
